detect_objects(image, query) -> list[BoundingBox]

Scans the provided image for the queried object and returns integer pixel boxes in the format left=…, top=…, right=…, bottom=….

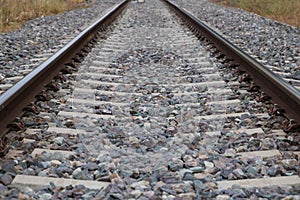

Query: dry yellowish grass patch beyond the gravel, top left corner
left=0, top=0, right=89, bottom=33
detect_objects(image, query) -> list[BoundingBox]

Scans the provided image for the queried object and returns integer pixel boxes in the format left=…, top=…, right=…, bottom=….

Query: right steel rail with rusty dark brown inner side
left=165, top=0, right=300, bottom=123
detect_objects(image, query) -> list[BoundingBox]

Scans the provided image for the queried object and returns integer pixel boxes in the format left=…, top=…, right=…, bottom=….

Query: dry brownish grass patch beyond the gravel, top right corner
left=211, top=0, right=300, bottom=28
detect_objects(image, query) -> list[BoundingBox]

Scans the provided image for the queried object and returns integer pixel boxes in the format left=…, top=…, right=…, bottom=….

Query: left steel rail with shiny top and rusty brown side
left=0, top=0, right=128, bottom=137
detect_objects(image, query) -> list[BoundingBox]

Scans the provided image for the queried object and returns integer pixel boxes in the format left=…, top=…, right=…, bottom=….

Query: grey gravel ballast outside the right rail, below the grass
left=173, top=0, right=300, bottom=84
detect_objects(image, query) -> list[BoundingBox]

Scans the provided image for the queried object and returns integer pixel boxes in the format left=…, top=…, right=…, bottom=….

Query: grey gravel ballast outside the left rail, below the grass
left=0, top=0, right=118, bottom=94
